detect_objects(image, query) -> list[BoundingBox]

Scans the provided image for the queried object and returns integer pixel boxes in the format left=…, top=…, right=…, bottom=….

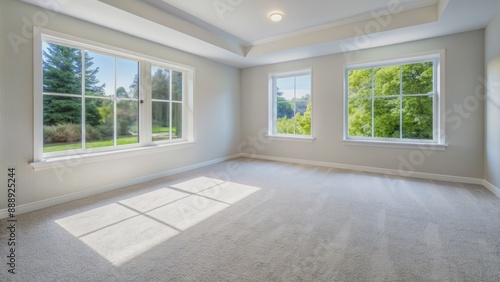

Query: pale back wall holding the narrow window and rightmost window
left=241, top=30, right=484, bottom=179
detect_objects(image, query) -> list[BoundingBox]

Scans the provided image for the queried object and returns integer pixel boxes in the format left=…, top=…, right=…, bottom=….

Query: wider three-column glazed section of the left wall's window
left=43, top=41, right=139, bottom=153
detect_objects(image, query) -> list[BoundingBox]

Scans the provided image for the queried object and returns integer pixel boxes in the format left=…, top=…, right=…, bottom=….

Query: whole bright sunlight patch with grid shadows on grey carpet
left=55, top=177, right=260, bottom=266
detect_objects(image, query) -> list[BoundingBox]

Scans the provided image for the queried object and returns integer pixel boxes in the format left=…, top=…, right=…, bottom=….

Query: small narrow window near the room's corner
left=269, top=70, right=312, bottom=137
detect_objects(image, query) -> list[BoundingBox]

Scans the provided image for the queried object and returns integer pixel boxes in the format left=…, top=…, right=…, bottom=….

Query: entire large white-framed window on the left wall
left=35, top=28, right=193, bottom=161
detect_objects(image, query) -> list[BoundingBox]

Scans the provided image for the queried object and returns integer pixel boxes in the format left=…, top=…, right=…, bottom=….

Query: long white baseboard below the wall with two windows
left=242, top=154, right=486, bottom=186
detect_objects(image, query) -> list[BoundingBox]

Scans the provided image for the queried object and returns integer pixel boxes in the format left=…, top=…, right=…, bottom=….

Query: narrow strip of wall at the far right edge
left=484, top=14, right=500, bottom=188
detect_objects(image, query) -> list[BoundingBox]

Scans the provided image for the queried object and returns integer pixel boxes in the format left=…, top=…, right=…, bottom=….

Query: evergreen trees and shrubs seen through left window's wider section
left=43, top=43, right=139, bottom=151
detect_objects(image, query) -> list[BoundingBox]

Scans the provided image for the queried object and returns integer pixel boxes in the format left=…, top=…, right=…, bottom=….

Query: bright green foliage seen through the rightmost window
left=348, top=62, right=433, bottom=139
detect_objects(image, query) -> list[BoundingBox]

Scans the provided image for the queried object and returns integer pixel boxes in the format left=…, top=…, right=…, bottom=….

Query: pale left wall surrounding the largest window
left=0, top=0, right=241, bottom=209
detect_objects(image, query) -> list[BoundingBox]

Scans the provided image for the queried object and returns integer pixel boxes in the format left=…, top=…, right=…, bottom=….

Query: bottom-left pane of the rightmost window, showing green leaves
left=348, top=99, right=372, bottom=137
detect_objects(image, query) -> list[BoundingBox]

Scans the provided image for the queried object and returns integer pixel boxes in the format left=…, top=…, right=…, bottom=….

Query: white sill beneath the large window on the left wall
left=30, top=141, right=195, bottom=171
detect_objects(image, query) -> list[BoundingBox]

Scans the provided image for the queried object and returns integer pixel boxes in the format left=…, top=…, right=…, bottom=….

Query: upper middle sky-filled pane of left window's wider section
left=85, top=51, right=115, bottom=97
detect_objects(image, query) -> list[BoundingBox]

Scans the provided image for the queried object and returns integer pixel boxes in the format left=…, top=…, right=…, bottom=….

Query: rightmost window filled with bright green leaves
left=344, top=55, right=444, bottom=143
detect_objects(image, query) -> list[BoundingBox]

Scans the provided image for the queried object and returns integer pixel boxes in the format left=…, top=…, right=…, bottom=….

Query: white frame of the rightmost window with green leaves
left=343, top=50, right=447, bottom=150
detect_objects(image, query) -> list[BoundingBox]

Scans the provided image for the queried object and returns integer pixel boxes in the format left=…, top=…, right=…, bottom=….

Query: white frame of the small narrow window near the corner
left=267, top=68, right=314, bottom=142
